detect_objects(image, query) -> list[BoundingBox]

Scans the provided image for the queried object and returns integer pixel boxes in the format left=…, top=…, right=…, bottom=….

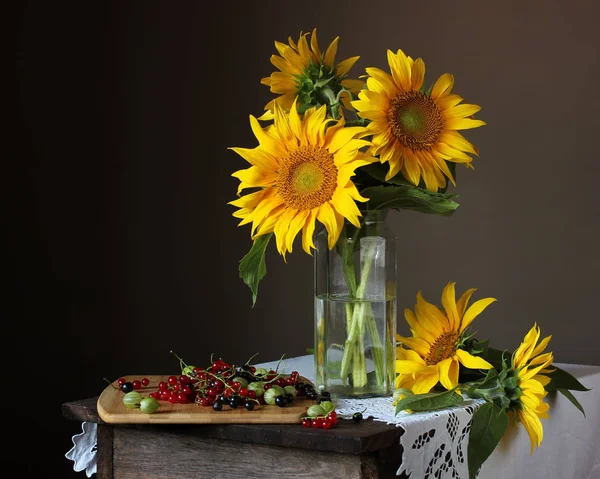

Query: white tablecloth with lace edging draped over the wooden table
left=66, top=355, right=600, bottom=479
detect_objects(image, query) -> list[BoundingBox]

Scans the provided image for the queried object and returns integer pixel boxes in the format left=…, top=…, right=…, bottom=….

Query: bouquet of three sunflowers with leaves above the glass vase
left=230, top=30, right=485, bottom=303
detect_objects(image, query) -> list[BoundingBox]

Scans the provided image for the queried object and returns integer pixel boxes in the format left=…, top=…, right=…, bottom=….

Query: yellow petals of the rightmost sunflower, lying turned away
left=512, top=324, right=554, bottom=454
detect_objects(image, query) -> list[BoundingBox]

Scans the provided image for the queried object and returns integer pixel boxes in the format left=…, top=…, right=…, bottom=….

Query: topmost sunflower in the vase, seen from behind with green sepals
left=259, top=28, right=364, bottom=120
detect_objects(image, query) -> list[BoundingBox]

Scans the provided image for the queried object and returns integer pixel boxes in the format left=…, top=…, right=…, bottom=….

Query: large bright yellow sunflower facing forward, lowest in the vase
left=230, top=102, right=374, bottom=257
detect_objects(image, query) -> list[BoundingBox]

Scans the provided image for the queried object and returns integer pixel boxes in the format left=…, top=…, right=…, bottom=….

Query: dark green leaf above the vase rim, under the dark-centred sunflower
left=360, top=185, right=458, bottom=216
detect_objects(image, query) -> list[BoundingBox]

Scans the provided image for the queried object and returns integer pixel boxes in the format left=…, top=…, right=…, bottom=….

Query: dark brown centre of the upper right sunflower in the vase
left=388, top=90, right=444, bottom=150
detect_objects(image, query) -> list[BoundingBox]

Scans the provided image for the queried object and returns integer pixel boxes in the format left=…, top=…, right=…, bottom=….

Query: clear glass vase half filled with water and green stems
left=314, top=210, right=396, bottom=398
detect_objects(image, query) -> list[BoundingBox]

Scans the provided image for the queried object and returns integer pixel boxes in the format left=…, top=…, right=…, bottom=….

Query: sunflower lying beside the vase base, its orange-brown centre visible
left=396, top=282, right=496, bottom=394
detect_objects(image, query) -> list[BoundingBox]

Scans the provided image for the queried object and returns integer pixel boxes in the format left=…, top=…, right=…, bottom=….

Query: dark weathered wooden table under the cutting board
left=62, top=397, right=403, bottom=479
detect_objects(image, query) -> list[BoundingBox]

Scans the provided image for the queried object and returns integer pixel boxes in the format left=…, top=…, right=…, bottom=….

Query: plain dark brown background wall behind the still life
left=14, top=0, right=600, bottom=477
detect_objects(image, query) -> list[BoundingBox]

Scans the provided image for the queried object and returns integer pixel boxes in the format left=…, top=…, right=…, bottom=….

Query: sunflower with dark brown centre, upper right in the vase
left=352, top=50, right=485, bottom=191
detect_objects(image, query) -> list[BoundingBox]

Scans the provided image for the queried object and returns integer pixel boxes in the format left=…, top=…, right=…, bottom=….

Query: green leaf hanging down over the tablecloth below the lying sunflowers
left=467, top=402, right=508, bottom=479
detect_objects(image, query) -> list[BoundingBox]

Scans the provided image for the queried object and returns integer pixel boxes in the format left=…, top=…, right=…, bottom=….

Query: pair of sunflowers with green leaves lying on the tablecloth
left=393, top=282, right=587, bottom=476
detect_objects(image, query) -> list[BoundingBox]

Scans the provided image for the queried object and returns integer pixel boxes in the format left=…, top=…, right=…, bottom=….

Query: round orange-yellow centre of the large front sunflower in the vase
left=278, top=146, right=337, bottom=210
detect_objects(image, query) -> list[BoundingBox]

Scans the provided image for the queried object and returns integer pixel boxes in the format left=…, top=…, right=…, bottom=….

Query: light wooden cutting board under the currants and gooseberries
left=98, top=375, right=316, bottom=424
